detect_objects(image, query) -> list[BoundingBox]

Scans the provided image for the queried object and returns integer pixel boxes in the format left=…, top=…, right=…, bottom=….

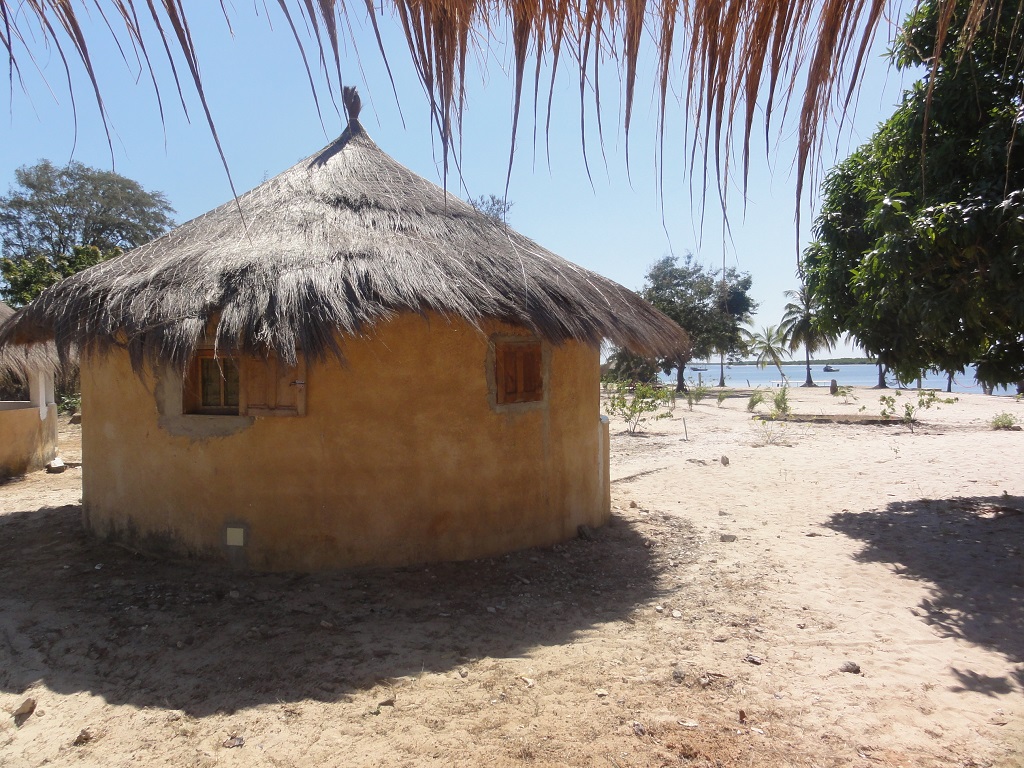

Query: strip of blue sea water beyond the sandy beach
left=662, top=362, right=1017, bottom=396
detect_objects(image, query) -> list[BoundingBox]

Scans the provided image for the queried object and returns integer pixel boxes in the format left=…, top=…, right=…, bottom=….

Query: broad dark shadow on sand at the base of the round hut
left=0, top=506, right=667, bottom=717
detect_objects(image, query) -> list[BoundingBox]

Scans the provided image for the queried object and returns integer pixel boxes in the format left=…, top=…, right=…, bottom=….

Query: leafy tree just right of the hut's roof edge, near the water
left=640, top=254, right=757, bottom=392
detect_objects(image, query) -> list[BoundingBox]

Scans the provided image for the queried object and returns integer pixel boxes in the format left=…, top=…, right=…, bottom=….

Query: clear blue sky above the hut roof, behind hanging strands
left=0, top=3, right=913, bottom=358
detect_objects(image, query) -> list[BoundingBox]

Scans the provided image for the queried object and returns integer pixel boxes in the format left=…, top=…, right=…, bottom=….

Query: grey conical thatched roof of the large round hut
left=0, top=89, right=687, bottom=367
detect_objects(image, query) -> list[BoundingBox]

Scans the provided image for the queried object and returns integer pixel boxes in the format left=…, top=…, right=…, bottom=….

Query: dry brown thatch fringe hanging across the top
left=6, top=0, right=1024, bottom=207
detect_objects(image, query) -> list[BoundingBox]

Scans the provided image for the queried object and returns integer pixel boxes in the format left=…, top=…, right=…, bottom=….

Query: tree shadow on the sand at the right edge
left=826, top=496, right=1024, bottom=671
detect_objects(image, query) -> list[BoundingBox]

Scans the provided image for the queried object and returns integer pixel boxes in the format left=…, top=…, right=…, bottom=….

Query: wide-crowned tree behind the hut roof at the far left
left=0, top=160, right=174, bottom=305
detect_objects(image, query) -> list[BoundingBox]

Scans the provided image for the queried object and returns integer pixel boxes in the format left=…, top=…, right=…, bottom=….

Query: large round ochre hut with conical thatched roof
left=0, top=89, right=687, bottom=570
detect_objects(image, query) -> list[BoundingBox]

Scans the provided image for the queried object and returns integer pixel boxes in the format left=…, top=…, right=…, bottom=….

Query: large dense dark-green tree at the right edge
left=803, top=0, right=1024, bottom=384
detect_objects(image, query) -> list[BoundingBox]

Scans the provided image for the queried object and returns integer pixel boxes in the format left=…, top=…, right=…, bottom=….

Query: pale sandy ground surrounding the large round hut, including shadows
left=0, top=389, right=1024, bottom=768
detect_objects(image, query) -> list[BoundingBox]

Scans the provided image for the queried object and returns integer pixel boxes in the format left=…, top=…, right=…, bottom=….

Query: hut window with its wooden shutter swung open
left=181, top=349, right=306, bottom=416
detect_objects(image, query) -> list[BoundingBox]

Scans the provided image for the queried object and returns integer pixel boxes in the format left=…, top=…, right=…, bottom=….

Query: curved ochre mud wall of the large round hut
left=82, top=315, right=609, bottom=570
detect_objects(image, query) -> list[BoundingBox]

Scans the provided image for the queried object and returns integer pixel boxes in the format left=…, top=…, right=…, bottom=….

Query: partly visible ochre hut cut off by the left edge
left=0, top=301, right=57, bottom=480
